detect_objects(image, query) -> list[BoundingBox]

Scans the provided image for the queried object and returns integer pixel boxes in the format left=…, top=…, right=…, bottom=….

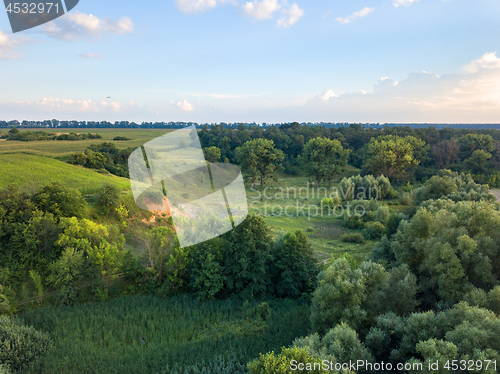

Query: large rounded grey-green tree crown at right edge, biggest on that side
left=391, top=200, right=500, bottom=304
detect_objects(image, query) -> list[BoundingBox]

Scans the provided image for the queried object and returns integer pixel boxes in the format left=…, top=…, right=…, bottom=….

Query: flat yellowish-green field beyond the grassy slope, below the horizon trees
left=0, top=129, right=173, bottom=157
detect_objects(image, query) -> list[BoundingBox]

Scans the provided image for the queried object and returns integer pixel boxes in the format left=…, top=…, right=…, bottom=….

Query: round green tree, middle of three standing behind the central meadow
left=302, top=137, right=349, bottom=187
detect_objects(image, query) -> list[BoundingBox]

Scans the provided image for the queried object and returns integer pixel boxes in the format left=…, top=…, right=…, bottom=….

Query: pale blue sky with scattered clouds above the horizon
left=0, top=0, right=500, bottom=123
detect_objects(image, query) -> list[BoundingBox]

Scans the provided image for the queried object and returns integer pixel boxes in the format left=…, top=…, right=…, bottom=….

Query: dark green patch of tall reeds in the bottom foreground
left=20, top=295, right=310, bottom=374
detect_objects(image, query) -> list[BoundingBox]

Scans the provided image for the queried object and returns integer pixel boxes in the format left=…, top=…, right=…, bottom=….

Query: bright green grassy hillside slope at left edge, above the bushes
left=0, top=153, right=130, bottom=194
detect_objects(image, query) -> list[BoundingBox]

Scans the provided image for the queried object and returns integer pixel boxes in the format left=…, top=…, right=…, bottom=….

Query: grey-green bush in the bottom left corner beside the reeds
left=0, top=316, right=52, bottom=372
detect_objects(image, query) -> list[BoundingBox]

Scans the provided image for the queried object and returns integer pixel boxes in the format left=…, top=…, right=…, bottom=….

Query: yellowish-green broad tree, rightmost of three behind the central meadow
left=365, top=135, right=425, bottom=184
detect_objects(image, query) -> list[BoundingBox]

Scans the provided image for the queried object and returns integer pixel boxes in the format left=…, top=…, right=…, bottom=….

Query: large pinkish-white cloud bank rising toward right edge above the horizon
left=300, top=53, right=500, bottom=123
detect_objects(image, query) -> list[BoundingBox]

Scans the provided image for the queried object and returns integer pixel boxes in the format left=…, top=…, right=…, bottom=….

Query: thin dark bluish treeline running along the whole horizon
left=0, top=119, right=500, bottom=130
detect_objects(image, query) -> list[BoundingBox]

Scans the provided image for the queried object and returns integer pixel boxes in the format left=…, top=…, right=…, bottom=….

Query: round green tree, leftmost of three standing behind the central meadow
left=236, top=139, right=284, bottom=189
